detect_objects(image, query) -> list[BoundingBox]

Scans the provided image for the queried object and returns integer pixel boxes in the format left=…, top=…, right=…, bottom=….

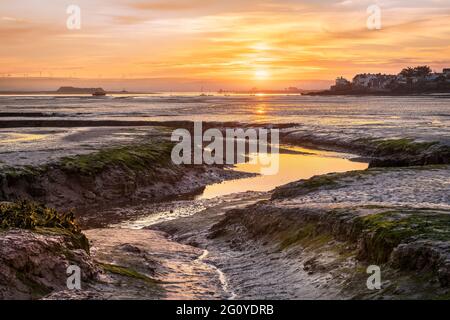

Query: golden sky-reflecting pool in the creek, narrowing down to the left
left=110, top=146, right=368, bottom=229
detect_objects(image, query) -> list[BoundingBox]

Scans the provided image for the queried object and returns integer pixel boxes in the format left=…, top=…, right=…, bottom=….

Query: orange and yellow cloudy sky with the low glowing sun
left=0, top=0, right=450, bottom=90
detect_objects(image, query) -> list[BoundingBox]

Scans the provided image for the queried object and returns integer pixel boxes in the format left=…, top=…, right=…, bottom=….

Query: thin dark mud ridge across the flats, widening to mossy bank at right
left=0, top=120, right=450, bottom=166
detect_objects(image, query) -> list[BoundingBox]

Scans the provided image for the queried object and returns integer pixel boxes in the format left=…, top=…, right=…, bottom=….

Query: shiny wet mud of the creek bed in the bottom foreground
left=86, top=229, right=229, bottom=300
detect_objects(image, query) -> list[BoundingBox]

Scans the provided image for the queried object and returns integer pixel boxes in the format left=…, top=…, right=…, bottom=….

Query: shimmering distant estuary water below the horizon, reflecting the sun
left=0, top=93, right=450, bottom=142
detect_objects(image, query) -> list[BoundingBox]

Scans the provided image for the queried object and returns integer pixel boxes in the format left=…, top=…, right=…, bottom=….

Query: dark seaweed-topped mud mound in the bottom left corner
left=0, top=229, right=99, bottom=299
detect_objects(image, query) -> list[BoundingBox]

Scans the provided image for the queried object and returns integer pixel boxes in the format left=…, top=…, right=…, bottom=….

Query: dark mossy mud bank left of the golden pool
left=0, top=138, right=248, bottom=219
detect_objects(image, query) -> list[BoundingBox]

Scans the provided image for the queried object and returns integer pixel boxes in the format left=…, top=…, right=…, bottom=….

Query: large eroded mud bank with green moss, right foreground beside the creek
left=209, top=167, right=450, bottom=299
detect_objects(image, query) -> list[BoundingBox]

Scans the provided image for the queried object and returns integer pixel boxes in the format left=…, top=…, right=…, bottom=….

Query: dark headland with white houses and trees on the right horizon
left=327, top=66, right=450, bottom=94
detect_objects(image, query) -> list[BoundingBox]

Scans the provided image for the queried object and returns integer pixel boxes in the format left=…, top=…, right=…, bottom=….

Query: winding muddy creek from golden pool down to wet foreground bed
left=86, top=147, right=368, bottom=299
